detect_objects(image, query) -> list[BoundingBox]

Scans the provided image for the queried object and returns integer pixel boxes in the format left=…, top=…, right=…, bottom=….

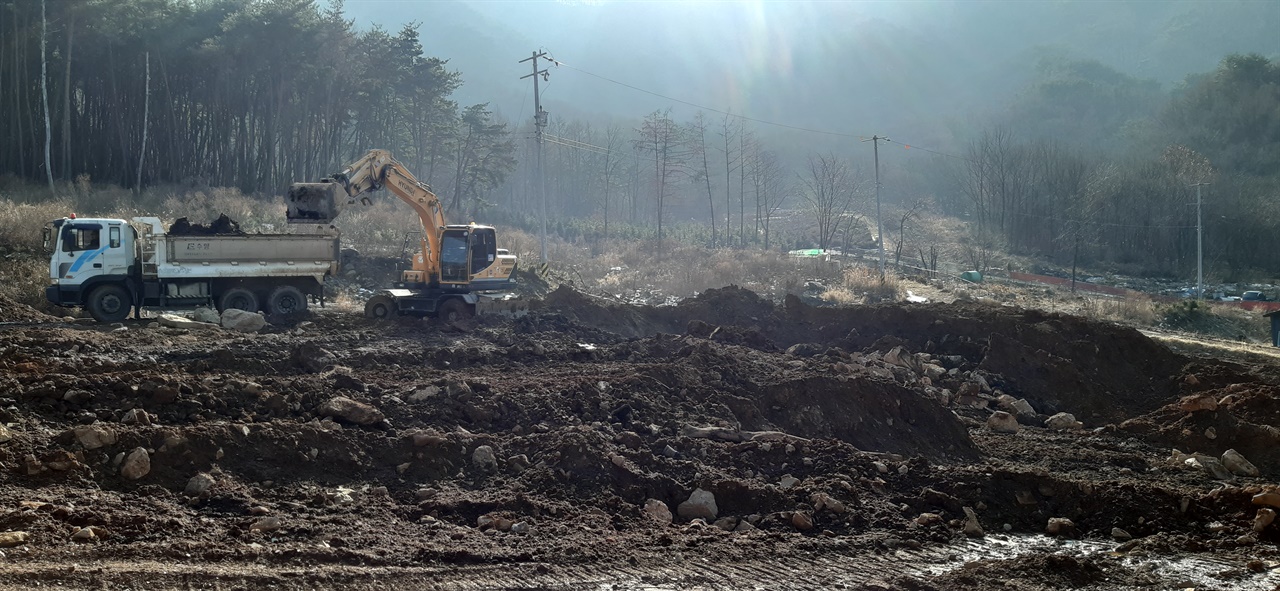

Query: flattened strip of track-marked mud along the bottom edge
left=0, top=535, right=1280, bottom=591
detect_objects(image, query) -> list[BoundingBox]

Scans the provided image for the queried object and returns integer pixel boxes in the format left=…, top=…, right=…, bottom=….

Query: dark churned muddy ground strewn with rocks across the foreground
left=0, top=288, right=1280, bottom=590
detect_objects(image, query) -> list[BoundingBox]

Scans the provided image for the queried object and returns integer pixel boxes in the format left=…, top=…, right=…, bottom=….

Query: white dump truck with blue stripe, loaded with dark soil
left=44, top=214, right=339, bottom=322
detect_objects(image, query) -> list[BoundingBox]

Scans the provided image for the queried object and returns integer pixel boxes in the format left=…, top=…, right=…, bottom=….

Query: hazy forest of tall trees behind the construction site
left=0, top=0, right=1280, bottom=280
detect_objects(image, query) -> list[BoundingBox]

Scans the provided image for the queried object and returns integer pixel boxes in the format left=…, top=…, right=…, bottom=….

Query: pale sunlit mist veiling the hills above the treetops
left=346, top=0, right=1280, bottom=147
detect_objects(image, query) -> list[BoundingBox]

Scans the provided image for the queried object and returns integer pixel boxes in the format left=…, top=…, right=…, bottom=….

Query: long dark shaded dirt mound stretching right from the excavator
left=545, top=287, right=1187, bottom=426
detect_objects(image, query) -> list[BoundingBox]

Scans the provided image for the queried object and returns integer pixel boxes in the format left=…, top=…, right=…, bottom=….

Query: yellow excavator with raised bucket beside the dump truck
left=285, top=150, right=516, bottom=321
